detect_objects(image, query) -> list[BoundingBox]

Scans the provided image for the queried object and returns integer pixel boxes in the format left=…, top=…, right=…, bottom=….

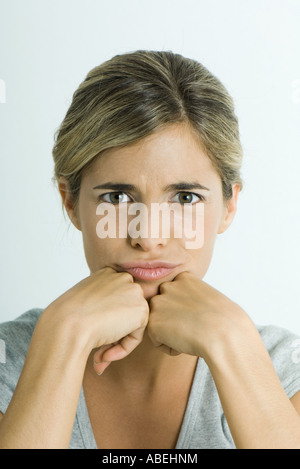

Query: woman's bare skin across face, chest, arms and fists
left=0, top=120, right=300, bottom=448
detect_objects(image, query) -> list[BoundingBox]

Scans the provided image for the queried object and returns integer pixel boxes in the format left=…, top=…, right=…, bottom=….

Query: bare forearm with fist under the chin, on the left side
left=0, top=268, right=149, bottom=449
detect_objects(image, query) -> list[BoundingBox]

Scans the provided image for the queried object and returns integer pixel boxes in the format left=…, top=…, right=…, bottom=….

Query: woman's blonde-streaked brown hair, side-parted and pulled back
left=53, top=50, right=242, bottom=204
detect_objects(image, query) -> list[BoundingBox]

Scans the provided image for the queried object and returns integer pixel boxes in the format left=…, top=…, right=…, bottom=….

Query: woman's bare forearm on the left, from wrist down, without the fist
left=0, top=308, right=86, bottom=449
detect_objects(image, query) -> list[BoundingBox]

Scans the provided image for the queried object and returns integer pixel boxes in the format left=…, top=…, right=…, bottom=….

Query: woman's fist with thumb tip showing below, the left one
left=43, top=267, right=149, bottom=374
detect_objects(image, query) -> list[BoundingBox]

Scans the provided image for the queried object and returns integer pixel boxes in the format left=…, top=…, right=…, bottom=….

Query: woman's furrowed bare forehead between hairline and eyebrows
left=83, top=124, right=218, bottom=183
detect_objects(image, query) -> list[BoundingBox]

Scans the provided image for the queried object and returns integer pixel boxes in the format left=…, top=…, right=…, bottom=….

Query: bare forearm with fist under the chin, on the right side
left=148, top=272, right=300, bottom=448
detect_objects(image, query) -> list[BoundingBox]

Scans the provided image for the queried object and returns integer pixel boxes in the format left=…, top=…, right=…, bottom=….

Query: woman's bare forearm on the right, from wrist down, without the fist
left=206, top=325, right=300, bottom=449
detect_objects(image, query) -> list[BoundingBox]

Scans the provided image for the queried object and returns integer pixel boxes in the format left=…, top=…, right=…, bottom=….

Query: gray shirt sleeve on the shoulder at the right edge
left=257, top=325, right=300, bottom=397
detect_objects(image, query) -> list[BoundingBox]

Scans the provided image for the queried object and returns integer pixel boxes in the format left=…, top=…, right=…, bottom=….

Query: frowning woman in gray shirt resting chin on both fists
left=0, top=51, right=300, bottom=449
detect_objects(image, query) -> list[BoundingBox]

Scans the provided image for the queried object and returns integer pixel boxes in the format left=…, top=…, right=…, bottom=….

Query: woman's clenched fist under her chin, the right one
left=147, top=272, right=246, bottom=358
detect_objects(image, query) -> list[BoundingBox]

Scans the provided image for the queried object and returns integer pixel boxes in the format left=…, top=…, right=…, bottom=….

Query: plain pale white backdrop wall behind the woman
left=0, top=0, right=300, bottom=333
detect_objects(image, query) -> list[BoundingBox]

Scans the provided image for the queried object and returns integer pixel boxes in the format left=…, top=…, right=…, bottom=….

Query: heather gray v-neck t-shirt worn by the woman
left=0, top=309, right=300, bottom=449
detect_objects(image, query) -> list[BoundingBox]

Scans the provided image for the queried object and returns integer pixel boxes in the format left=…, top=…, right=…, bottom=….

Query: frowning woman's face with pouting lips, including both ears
left=59, top=124, right=239, bottom=299
